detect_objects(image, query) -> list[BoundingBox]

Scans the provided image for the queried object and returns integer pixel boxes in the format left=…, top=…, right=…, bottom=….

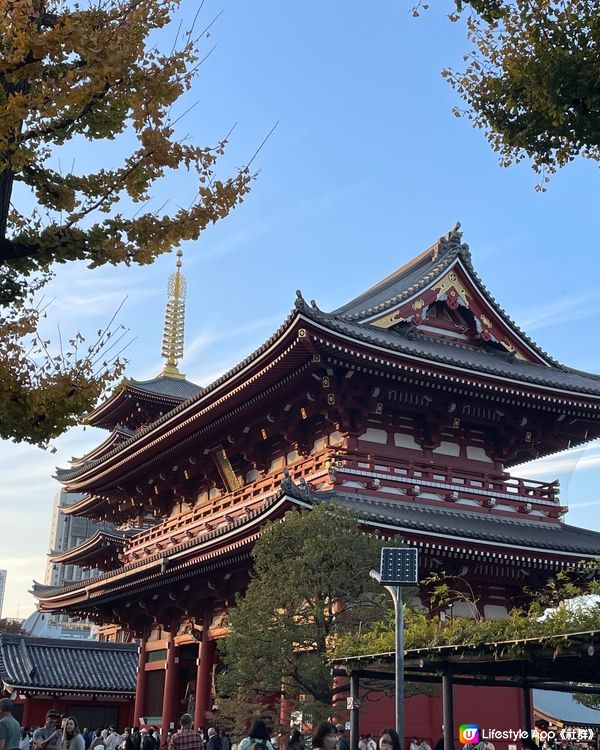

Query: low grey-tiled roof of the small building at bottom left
left=0, top=633, right=138, bottom=696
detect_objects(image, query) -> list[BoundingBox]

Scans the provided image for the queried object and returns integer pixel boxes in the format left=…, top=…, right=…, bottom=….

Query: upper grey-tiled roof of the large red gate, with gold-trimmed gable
left=56, top=227, right=600, bottom=490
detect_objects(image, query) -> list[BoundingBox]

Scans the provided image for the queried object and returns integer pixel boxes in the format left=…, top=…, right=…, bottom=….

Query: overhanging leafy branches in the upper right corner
left=443, top=0, right=600, bottom=189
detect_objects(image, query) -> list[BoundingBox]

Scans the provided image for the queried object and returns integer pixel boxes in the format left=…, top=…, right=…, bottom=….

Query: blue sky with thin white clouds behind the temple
left=0, top=0, right=600, bottom=616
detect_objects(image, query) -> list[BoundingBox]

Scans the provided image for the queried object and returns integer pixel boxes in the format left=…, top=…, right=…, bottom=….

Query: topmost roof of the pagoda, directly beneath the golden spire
left=84, top=374, right=202, bottom=429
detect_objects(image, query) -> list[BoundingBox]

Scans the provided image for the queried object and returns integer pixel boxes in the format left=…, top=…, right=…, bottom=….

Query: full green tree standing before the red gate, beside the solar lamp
left=218, top=504, right=389, bottom=719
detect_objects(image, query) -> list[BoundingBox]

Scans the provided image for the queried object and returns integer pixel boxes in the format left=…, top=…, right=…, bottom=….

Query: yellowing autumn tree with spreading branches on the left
left=0, top=0, right=251, bottom=445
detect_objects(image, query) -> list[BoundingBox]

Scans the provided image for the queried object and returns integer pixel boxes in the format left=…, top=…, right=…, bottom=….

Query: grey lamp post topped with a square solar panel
left=369, top=547, right=419, bottom=750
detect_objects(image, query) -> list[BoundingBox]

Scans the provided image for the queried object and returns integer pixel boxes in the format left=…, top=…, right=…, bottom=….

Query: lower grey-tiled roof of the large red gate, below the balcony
left=32, top=478, right=600, bottom=611
